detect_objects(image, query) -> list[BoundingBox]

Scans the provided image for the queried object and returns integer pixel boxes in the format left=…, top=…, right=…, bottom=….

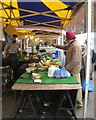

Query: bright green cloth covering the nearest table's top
left=16, top=71, right=78, bottom=84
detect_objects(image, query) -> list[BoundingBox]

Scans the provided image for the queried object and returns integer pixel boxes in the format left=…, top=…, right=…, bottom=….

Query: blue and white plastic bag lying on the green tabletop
left=54, top=69, right=70, bottom=78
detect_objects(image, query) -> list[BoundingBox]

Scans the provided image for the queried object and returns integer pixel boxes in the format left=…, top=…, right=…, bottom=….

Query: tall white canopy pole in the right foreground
left=83, top=0, right=91, bottom=118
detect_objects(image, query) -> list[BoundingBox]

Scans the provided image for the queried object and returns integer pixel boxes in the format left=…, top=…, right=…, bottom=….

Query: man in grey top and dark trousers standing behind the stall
left=4, top=34, right=19, bottom=77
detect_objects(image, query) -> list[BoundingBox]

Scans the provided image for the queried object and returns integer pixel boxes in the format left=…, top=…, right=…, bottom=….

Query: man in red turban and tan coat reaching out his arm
left=52, top=32, right=82, bottom=107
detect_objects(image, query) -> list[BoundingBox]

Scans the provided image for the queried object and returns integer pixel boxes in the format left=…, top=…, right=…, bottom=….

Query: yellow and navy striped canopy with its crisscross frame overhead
left=0, top=0, right=91, bottom=117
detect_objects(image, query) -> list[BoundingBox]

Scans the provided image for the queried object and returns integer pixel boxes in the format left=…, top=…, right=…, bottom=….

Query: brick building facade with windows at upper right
left=64, top=2, right=96, bottom=34
